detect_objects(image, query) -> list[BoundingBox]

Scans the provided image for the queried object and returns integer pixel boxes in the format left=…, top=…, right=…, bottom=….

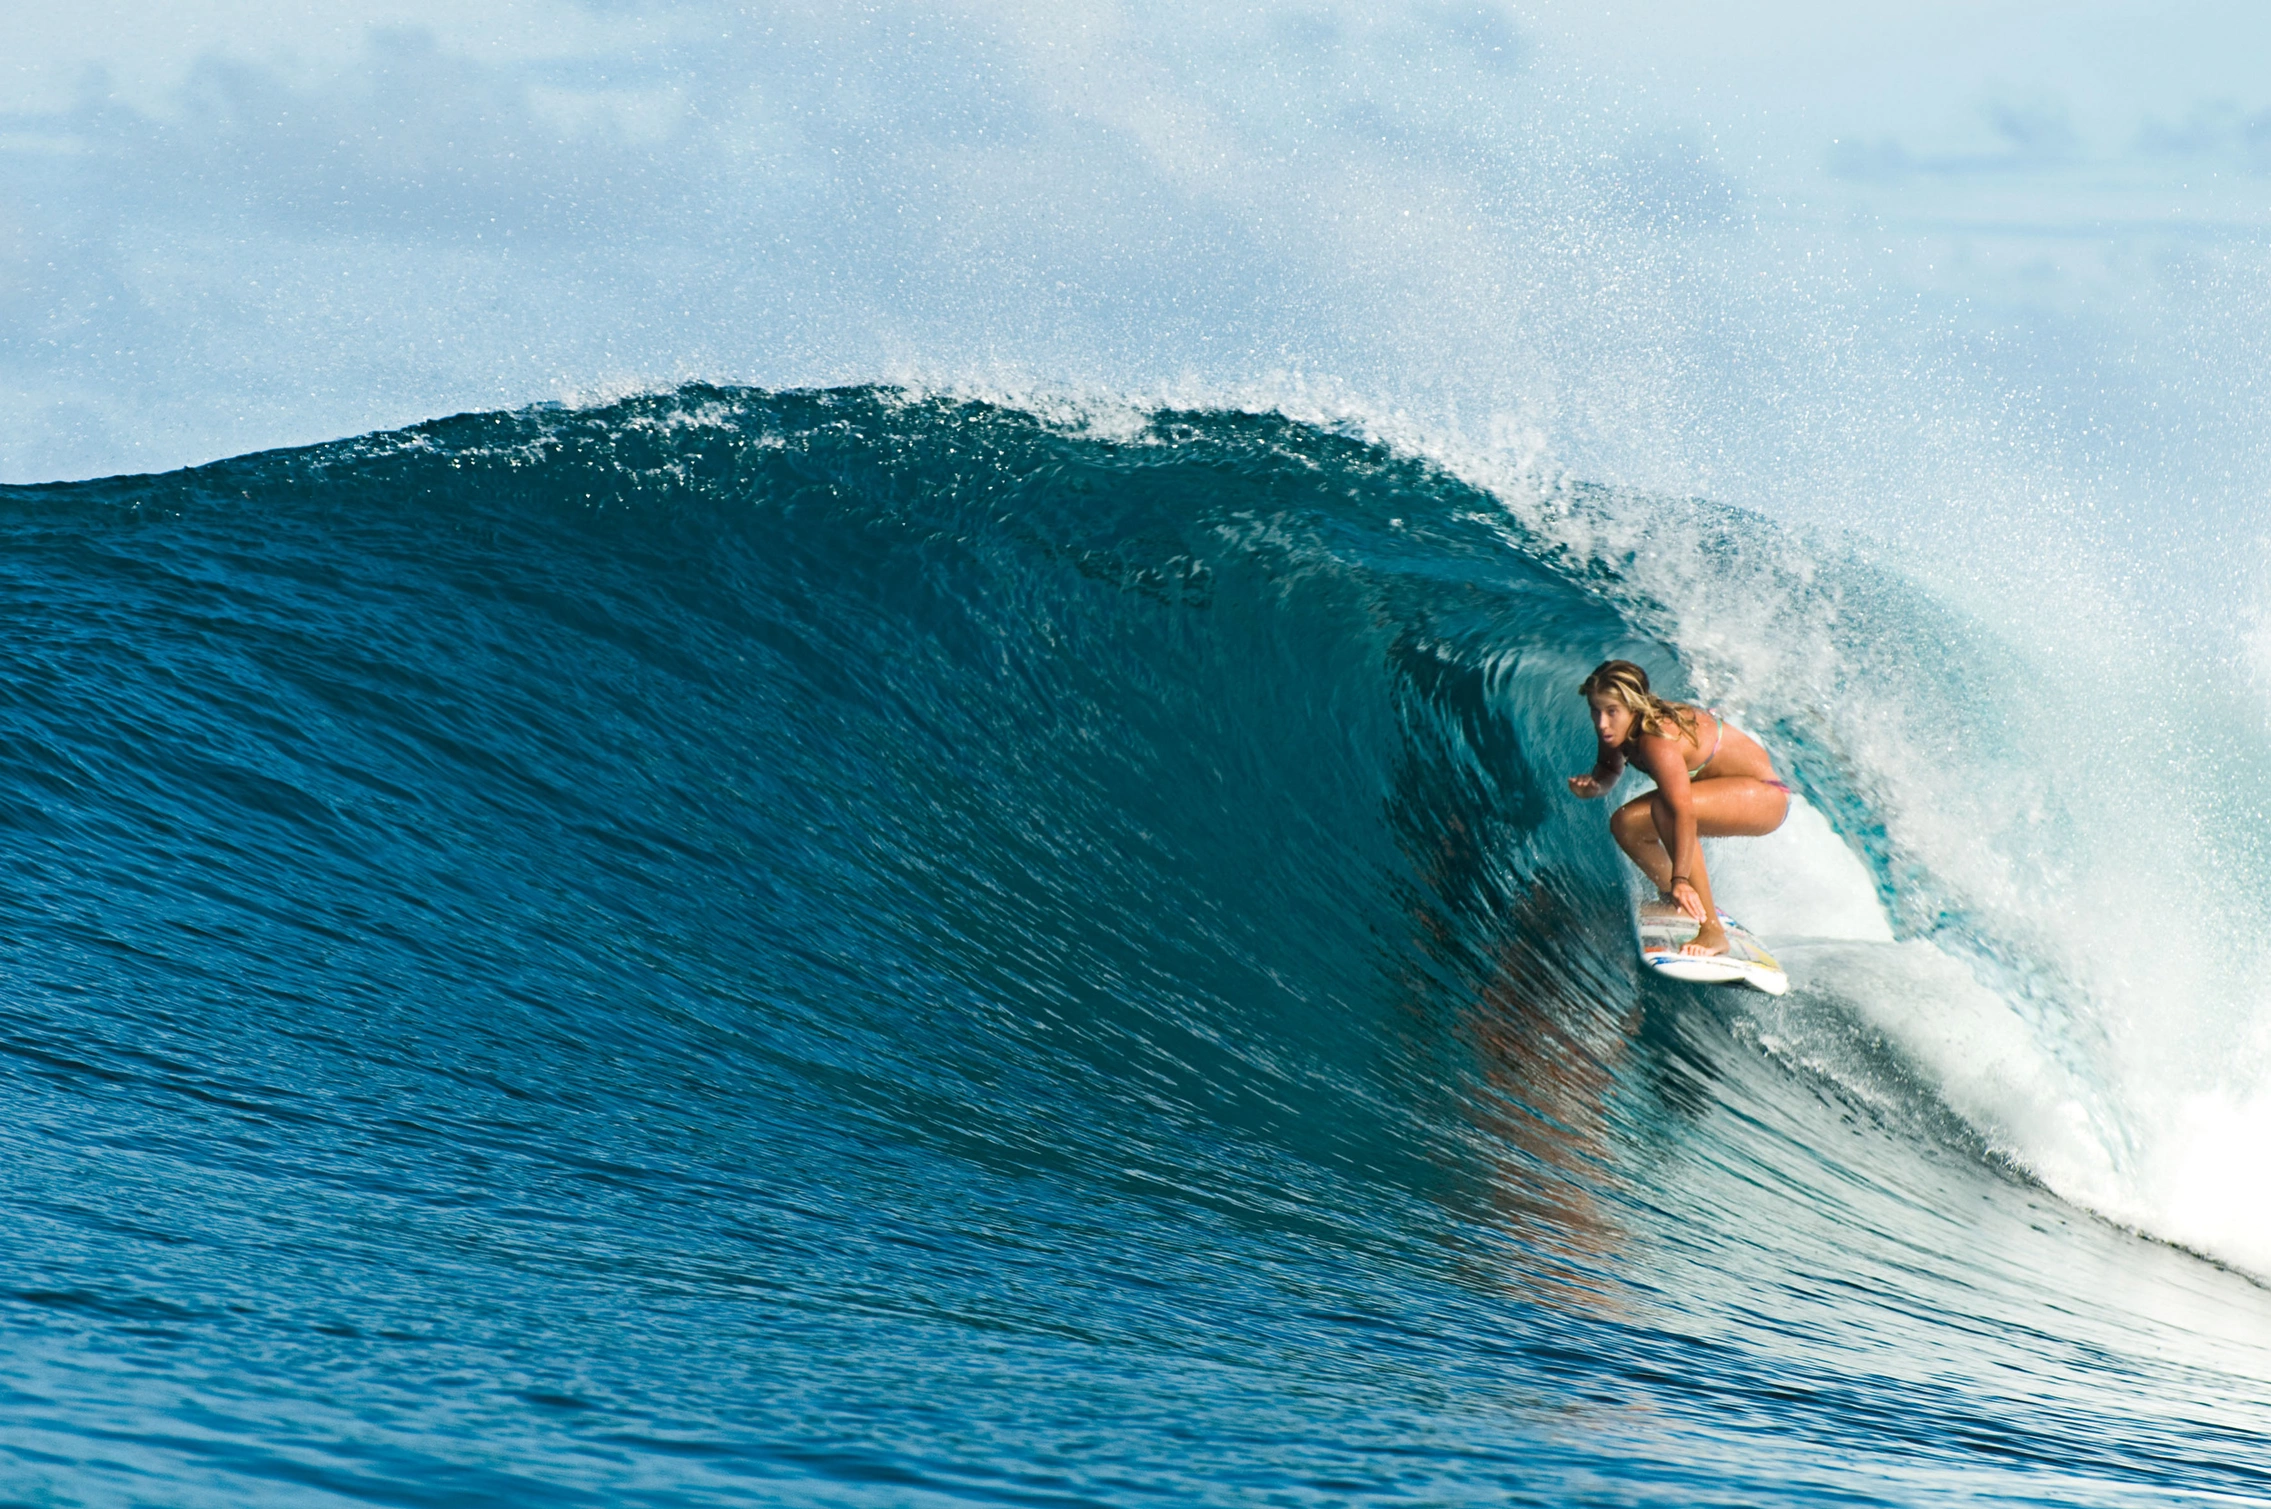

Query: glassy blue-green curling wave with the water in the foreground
left=0, top=389, right=2271, bottom=1504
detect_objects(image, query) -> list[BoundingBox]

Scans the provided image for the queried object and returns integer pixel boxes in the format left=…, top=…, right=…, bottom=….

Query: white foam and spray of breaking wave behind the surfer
left=1144, top=384, right=2271, bottom=1277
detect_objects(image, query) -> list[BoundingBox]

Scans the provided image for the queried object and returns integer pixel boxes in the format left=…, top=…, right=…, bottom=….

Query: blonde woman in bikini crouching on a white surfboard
left=1569, top=661, right=1790, bottom=954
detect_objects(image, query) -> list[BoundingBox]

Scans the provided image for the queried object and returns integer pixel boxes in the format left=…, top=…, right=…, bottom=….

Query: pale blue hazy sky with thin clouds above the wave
left=0, top=0, right=2271, bottom=548
